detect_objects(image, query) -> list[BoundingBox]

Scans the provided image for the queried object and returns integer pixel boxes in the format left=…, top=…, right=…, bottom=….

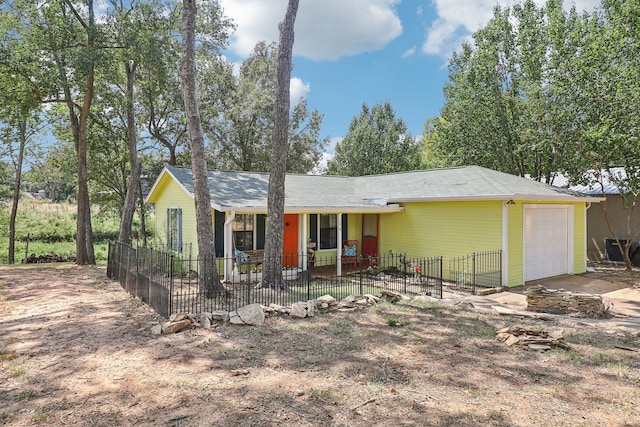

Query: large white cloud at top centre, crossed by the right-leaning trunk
left=220, top=0, right=402, bottom=60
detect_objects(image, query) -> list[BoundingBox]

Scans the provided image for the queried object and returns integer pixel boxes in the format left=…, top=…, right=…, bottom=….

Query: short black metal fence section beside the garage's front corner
left=447, top=251, right=502, bottom=292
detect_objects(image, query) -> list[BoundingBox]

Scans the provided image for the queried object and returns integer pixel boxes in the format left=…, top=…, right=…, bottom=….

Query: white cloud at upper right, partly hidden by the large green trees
left=422, top=0, right=600, bottom=56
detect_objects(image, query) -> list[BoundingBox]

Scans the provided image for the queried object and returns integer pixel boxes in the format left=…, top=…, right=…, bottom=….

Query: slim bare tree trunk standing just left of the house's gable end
left=118, top=62, right=140, bottom=245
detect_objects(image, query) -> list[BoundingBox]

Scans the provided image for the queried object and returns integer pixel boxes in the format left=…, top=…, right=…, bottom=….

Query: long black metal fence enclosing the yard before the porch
left=107, top=243, right=442, bottom=317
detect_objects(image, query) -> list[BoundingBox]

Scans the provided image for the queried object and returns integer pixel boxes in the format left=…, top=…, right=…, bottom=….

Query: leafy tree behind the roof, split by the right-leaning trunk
left=210, top=42, right=327, bottom=173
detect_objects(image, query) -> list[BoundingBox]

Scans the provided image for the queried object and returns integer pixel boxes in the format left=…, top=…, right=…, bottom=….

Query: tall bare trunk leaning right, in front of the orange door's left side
left=262, top=0, right=298, bottom=288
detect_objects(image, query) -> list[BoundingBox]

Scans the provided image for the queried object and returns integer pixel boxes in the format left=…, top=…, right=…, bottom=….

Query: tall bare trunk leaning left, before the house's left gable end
left=180, top=0, right=224, bottom=298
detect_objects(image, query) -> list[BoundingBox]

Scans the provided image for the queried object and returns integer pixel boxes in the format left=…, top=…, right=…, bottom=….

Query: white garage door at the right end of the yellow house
left=524, top=205, right=573, bottom=282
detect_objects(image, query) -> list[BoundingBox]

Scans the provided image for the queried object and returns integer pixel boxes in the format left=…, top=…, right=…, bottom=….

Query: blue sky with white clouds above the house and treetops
left=220, top=0, right=599, bottom=154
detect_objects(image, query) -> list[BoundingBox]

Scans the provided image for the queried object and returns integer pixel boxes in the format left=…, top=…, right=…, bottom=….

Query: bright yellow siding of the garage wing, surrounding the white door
left=379, top=201, right=585, bottom=286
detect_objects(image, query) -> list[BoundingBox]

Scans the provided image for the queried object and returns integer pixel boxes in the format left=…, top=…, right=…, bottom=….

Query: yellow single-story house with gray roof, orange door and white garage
left=146, top=166, right=602, bottom=286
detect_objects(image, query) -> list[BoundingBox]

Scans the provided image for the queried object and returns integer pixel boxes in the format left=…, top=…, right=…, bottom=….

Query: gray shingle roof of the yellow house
left=160, top=166, right=599, bottom=212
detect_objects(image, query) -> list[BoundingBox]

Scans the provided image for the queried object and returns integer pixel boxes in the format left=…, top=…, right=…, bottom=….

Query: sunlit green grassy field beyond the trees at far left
left=0, top=201, right=151, bottom=264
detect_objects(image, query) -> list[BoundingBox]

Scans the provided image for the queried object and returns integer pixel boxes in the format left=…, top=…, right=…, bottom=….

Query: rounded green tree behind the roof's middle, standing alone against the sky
left=327, top=101, right=422, bottom=176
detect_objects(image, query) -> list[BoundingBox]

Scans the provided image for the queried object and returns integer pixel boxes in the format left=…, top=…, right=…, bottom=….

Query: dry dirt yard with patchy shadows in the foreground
left=0, top=264, right=640, bottom=427
